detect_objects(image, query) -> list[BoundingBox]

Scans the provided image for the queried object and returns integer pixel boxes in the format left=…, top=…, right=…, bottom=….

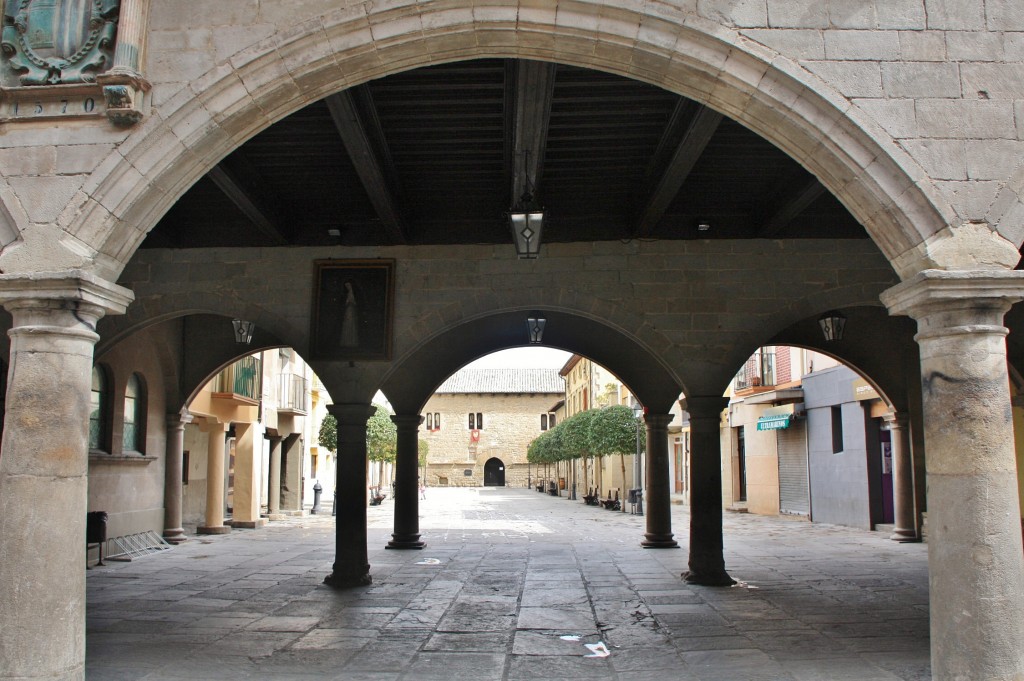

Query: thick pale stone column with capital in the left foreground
left=0, top=271, right=132, bottom=679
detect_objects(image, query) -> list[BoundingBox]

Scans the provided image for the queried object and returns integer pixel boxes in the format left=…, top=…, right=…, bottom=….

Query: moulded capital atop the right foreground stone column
left=880, top=269, right=1024, bottom=318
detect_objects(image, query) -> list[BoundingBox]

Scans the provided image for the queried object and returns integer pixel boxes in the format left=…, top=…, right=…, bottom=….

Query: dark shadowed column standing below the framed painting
left=324, top=403, right=376, bottom=588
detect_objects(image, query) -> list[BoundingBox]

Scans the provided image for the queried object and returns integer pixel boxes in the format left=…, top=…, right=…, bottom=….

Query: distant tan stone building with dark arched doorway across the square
left=421, top=369, right=565, bottom=487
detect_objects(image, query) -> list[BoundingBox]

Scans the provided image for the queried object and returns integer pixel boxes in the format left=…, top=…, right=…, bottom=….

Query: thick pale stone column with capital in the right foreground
left=882, top=270, right=1024, bottom=681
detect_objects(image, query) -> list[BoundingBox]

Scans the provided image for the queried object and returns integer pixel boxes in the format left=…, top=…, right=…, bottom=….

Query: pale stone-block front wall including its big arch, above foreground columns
left=0, top=0, right=1024, bottom=278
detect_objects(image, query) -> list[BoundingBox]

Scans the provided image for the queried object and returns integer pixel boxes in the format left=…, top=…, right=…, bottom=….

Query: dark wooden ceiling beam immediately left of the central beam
left=325, top=86, right=409, bottom=244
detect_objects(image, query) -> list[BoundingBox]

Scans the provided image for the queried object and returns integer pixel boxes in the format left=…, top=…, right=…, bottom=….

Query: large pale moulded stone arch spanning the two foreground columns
left=34, top=0, right=958, bottom=279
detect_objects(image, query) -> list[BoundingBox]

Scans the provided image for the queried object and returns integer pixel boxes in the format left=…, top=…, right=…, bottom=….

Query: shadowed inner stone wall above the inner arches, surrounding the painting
left=108, top=240, right=897, bottom=399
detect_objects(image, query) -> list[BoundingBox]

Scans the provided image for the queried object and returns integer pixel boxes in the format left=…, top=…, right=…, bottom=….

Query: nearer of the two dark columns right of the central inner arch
left=682, top=395, right=735, bottom=587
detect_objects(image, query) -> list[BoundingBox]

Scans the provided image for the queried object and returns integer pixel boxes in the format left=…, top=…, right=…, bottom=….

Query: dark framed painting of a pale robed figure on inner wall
left=310, top=259, right=394, bottom=361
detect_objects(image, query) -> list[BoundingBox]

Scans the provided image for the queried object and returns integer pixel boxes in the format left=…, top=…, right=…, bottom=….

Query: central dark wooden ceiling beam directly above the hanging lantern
left=511, top=59, right=555, bottom=204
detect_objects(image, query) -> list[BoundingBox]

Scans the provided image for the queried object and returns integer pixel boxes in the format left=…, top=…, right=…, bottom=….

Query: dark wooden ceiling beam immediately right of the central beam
left=633, top=98, right=722, bottom=238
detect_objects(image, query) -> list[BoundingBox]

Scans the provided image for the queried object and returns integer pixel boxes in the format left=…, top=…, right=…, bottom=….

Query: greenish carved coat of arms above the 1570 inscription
left=0, top=0, right=120, bottom=85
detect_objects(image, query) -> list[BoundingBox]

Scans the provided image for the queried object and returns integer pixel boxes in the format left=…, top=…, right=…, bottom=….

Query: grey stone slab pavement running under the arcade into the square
left=86, top=487, right=930, bottom=681
